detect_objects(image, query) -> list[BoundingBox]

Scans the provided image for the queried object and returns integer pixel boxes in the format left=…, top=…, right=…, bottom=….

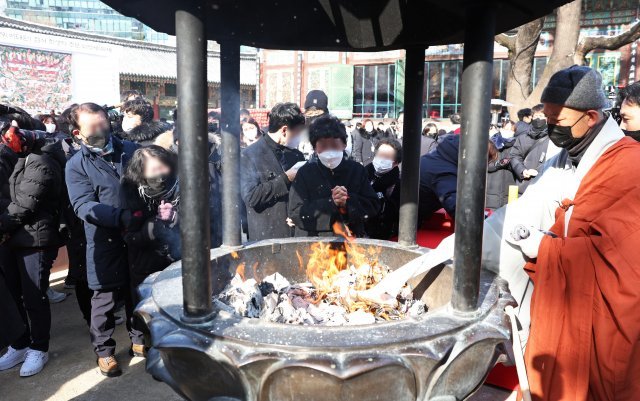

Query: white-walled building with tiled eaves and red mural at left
left=0, top=17, right=258, bottom=119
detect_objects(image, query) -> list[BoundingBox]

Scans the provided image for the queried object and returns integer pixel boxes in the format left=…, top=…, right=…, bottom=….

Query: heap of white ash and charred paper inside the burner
left=214, top=264, right=427, bottom=326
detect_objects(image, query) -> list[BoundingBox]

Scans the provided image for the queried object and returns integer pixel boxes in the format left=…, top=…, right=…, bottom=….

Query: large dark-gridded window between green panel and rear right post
left=353, top=64, right=396, bottom=118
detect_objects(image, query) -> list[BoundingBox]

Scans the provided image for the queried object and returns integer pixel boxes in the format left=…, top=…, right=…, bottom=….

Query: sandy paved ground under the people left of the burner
left=0, top=268, right=515, bottom=401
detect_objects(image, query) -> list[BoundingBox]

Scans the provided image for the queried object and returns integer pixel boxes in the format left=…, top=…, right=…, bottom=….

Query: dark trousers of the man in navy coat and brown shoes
left=89, top=287, right=144, bottom=358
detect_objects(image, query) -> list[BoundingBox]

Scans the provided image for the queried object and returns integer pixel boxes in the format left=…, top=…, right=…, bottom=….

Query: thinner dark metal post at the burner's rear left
left=220, top=42, right=242, bottom=246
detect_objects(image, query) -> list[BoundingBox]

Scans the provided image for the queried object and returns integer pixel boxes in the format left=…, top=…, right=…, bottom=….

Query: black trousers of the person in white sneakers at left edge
left=0, top=247, right=58, bottom=352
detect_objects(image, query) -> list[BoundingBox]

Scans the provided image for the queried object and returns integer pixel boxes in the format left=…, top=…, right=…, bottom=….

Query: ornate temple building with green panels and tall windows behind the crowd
left=258, top=0, right=640, bottom=118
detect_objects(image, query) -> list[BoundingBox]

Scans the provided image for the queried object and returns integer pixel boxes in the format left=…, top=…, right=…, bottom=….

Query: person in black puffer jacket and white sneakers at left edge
left=0, top=118, right=65, bottom=377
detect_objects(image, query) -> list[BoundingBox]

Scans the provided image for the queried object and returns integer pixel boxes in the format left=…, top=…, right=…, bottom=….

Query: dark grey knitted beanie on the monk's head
left=540, top=65, right=609, bottom=110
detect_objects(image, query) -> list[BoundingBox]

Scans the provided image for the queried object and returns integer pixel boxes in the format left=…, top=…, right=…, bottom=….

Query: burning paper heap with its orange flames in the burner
left=214, top=233, right=427, bottom=326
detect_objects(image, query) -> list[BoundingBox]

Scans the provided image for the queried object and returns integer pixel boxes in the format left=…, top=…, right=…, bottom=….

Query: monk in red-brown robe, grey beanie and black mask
left=502, top=66, right=640, bottom=401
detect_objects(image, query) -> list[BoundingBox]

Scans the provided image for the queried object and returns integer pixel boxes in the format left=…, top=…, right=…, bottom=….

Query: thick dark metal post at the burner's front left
left=176, top=7, right=212, bottom=320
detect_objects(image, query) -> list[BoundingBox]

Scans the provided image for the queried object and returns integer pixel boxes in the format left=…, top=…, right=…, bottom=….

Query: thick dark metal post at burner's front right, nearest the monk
left=451, top=2, right=495, bottom=312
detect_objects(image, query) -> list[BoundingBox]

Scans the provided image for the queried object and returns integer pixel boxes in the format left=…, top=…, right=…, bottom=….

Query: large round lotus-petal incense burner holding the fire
left=137, top=238, right=515, bottom=401
